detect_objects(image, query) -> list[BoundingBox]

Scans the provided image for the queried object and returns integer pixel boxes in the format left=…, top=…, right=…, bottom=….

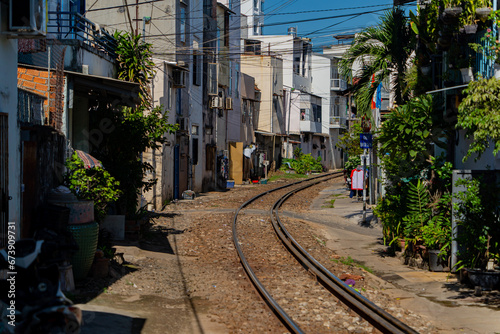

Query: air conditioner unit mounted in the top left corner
left=5, top=0, right=47, bottom=38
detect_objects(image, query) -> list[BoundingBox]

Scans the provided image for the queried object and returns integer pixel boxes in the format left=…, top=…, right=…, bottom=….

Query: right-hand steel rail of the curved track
left=271, top=182, right=418, bottom=333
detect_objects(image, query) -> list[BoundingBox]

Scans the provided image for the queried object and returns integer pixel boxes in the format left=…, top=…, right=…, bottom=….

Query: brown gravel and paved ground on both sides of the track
left=76, top=181, right=500, bottom=334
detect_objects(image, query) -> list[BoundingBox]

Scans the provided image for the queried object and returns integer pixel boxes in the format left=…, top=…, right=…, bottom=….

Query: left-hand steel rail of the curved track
left=233, top=172, right=342, bottom=334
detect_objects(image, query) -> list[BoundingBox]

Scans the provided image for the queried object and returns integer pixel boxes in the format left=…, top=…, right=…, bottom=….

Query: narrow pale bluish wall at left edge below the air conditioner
left=0, top=35, right=21, bottom=237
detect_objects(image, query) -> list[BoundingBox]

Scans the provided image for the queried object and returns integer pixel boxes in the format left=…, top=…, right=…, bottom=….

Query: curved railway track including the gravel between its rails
left=232, top=172, right=417, bottom=333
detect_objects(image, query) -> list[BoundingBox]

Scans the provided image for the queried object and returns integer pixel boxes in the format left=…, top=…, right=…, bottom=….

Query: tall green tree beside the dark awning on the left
left=91, top=32, right=178, bottom=216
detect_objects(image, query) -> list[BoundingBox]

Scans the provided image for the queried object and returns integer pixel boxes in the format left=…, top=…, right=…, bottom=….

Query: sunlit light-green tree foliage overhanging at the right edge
left=457, top=78, right=500, bottom=161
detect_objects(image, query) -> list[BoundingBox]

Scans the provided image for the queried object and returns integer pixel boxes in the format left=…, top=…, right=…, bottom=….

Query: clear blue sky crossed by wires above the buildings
left=264, top=0, right=416, bottom=47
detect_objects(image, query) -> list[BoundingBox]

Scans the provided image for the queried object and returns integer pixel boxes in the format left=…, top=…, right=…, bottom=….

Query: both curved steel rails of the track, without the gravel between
left=232, top=172, right=417, bottom=333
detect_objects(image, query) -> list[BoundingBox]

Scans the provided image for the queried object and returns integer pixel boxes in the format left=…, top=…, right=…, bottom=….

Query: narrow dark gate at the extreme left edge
left=0, top=113, right=9, bottom=248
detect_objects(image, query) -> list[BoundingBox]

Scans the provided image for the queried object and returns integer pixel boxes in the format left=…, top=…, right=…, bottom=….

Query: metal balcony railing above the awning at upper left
left=47, top=12, right=117, bottom=58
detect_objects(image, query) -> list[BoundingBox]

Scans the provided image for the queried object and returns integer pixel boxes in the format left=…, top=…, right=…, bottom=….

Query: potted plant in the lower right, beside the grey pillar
left=454, top=178, right=500, bottom=289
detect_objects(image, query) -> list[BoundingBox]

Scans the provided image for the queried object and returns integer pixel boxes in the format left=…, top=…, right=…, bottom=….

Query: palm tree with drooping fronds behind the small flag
left=339, top=8, right=415, bottom=115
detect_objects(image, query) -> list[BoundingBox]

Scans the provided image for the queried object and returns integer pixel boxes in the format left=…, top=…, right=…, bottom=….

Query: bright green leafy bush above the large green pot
left=65, top=152, right=121, bottom=222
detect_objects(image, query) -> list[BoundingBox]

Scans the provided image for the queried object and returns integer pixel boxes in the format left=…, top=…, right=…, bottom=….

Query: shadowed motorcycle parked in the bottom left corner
left=0, top=230, right=82, bottom=334
